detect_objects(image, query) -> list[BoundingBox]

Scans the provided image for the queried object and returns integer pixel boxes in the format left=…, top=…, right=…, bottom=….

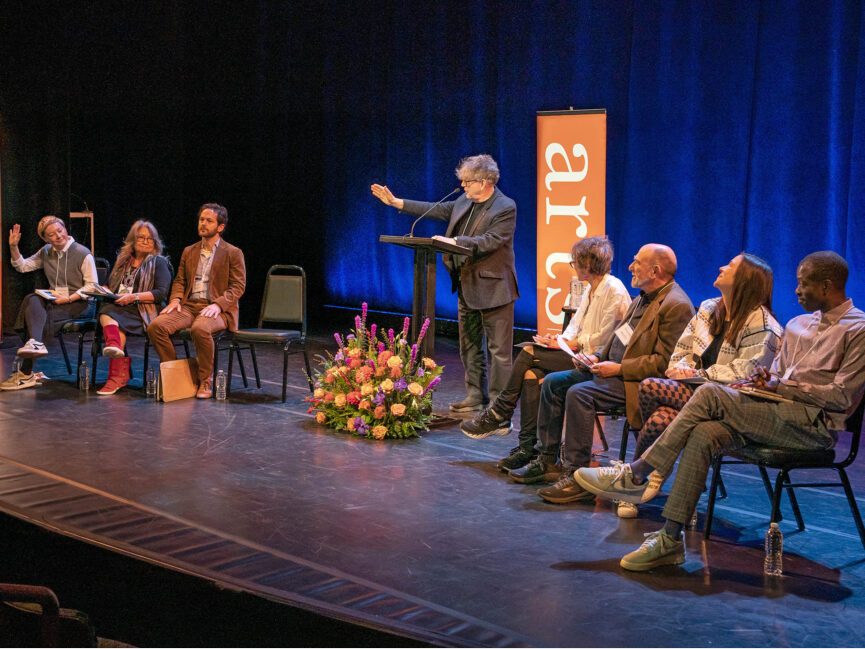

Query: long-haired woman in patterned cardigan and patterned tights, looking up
left=617, top=252, right=784, bottom=518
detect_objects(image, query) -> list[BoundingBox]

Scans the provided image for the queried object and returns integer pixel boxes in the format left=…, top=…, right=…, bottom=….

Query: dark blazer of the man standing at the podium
left=402, top=187, right=520, bottom=309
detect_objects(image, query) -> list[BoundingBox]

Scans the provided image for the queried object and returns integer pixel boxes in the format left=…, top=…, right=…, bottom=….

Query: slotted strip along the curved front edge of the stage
left=0, top=456, right=532, bottom=647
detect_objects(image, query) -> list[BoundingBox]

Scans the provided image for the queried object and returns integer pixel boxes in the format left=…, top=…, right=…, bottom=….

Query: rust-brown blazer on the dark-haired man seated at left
left=168, top=239, right=246, bottom=331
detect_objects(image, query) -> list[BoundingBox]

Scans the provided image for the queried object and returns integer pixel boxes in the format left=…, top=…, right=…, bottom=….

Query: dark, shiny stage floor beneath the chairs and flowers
left=0, top=338, right=865, bottom=647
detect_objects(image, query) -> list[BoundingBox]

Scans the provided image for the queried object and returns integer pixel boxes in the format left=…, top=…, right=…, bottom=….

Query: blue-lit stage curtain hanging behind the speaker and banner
left=322, top=0, right=865, bottom=327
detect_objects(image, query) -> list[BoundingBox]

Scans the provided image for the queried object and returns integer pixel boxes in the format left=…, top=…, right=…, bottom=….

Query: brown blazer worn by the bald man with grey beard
left=601, top=282, right=694, bottom=428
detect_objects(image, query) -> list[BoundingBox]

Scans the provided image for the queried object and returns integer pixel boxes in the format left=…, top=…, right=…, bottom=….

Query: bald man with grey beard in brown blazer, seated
left=510, top=243, right=694, bottom=503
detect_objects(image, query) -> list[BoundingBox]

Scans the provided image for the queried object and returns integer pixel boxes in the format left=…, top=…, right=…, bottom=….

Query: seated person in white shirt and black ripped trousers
left=461, top=237, right=631, bottom=471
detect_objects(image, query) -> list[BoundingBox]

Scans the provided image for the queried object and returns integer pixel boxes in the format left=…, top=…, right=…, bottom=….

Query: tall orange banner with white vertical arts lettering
left=537, top=108, right=607, bottom=333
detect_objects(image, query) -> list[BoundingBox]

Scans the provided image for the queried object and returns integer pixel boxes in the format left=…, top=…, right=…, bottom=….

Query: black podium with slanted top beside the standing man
left=378, top=235, right=472, bottom=357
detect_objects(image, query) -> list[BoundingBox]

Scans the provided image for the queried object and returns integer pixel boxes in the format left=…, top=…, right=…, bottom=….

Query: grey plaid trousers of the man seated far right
left=643, top=383, right=835, bottom=524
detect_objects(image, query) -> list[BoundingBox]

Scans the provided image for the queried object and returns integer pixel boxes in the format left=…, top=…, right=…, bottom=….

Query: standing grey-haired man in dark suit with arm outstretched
left=371, top=154, right=519, bottom=412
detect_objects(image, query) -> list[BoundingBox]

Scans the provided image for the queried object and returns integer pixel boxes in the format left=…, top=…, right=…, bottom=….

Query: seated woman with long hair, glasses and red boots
left=97, top=220, right=171, bottom=395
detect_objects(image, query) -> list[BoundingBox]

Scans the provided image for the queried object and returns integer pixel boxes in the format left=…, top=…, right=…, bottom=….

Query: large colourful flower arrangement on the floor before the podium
left=307, top=302, right=444, bottom=439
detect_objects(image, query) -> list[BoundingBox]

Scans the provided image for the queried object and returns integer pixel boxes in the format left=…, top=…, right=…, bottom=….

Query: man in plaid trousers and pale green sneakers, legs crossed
left=574, top=251, right=865, bottom=571
